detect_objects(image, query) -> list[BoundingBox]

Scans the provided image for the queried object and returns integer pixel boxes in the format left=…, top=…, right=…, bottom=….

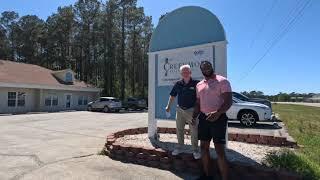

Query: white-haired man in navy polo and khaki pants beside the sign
left=166, top=65, right=201, bottom=159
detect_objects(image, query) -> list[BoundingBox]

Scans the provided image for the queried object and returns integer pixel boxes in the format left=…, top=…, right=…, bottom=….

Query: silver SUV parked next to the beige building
left=87, top=97, right=122, bottom=112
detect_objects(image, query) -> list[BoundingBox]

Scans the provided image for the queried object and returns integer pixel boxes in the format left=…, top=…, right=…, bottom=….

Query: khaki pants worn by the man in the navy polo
left=176, top=107, right=198, bottom=151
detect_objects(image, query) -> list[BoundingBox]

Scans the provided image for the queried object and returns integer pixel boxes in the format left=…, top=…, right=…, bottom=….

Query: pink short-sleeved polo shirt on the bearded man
left=197, top=75, right=232, bottom=113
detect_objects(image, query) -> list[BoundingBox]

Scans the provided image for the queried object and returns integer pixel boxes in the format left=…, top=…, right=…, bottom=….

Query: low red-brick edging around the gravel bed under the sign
left=105, top=127, right=302, bottom=180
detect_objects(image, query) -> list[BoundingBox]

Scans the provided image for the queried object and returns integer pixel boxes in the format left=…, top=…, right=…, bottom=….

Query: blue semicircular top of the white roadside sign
left=149, top=6, right=226, bottom=52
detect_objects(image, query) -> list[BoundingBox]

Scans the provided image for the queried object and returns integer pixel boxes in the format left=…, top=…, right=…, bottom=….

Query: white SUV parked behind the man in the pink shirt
left=227, top=97, right=272, bottom=127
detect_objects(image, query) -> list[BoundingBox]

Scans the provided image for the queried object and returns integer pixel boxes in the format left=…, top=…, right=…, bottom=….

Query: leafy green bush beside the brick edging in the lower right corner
left=263, top=149, right=320, bottom=179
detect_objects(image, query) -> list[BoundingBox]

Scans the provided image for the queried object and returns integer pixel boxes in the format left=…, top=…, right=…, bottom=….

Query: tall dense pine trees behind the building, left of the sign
left=0, top=0, right=153, bottom=99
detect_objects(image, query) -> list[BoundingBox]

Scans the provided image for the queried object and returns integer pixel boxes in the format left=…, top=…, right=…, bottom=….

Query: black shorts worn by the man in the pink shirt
left=198, top=113, right=228, bottom=144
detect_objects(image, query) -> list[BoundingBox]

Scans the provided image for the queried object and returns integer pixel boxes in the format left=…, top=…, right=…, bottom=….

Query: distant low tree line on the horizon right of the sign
left=241, top=91, right=316, bottom=102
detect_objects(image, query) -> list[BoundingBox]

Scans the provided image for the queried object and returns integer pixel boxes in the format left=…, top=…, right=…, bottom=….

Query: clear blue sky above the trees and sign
left=0, top=0, right=320, bottom=94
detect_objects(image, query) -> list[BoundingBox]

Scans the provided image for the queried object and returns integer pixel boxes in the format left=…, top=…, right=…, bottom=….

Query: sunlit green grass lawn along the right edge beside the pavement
left=273, top=104, right=320, bottom=179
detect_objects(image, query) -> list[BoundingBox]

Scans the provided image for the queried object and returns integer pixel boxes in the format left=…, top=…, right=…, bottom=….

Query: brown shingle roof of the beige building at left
left=0, top=60, right=93, bottom=88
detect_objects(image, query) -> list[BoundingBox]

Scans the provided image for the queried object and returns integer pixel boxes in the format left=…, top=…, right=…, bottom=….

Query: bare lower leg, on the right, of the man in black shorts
left=214, top=143, right=228, bottom=180
